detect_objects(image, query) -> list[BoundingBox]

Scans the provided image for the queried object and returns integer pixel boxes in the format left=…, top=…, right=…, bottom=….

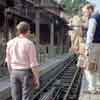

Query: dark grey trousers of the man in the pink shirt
left=10, top=70, right=33, bottom=100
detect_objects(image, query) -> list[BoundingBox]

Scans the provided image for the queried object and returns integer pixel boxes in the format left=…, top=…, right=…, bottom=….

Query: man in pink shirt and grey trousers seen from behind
left=6, top=21, right=40, bottom=100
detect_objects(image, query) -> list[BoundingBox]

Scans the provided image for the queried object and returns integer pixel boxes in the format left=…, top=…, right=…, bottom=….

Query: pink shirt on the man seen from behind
left=6, top=37, right=39, bottom=69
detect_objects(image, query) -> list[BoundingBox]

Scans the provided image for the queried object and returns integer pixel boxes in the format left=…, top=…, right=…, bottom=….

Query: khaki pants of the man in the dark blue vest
left=85, top=43, right=100, bottom=90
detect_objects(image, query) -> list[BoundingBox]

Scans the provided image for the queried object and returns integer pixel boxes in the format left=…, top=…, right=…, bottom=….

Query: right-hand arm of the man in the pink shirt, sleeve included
left=29, top=45, right=40, bottom=88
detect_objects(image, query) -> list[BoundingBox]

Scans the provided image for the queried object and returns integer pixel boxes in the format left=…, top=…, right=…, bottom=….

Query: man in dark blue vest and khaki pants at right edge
left=82, top=4, right=100, bottom=93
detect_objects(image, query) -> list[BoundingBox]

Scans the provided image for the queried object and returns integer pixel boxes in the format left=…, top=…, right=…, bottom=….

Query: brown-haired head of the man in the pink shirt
left=16, top=21, right=30, bottom=34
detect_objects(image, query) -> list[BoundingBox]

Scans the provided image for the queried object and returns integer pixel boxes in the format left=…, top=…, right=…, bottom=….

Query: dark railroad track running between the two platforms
left=8, top=56, right=82, bottom=100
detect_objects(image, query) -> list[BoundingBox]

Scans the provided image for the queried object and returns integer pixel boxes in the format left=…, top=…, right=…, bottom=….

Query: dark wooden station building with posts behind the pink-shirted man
left=0, top=0, right=69, bottom=63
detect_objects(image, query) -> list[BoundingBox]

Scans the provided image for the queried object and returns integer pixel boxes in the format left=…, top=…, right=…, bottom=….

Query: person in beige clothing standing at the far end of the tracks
left=71, top=15, right=85, bottom=62
